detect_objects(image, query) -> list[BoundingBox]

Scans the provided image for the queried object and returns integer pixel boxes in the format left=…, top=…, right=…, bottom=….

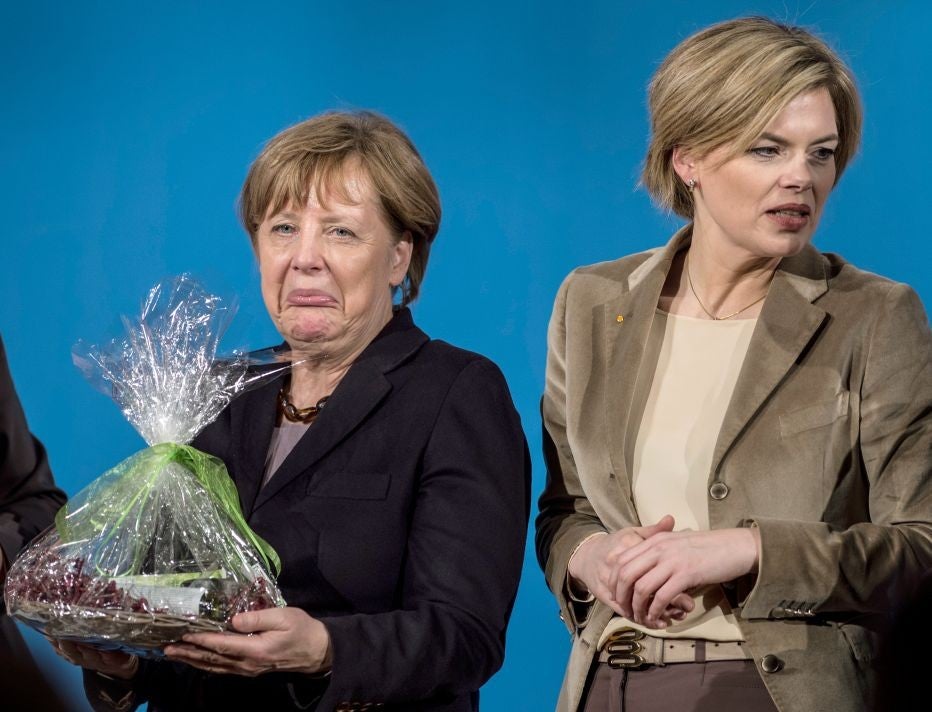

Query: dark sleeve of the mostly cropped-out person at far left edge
left=0, top=334, right=66, bottom=580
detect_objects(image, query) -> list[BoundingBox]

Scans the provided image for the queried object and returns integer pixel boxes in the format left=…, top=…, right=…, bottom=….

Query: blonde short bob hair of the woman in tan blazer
left=641, top=17, right=861, bottom=218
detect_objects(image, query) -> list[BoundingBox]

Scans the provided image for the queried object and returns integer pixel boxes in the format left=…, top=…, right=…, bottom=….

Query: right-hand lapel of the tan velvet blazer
left=709, top=246, right=828, bottom=479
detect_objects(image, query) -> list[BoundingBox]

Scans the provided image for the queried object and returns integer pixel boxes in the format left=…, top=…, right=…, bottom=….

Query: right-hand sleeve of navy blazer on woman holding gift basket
left=321, top=359, right=530, bottom=708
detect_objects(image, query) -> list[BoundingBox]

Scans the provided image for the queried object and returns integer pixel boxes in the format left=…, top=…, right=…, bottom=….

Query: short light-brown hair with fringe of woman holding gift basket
left=239, top=111, right=440, bottom=305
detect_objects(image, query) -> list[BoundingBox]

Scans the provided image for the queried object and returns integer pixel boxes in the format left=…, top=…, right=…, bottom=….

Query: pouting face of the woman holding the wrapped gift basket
left=256, top=169, right=411, bottom=359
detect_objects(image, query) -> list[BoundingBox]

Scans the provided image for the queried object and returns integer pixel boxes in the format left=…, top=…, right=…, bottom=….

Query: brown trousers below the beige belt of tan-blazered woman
left=584, top=660, right=777, bottom=712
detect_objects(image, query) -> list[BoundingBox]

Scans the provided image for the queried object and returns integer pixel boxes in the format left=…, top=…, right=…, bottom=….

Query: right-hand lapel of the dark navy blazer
left=252, top=309, right=428, bottom=509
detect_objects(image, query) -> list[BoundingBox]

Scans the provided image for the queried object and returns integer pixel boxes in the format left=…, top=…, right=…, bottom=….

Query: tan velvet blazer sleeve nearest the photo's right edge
left=742, top=284, right=932, bottom=618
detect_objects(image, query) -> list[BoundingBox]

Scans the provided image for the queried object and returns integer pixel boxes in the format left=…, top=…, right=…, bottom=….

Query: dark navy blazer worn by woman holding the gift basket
left=118, top=309, right=530, bottom=711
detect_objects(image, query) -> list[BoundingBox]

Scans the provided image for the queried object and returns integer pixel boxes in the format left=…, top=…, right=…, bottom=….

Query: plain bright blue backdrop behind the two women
left=0, top=0, right=932, bottom=712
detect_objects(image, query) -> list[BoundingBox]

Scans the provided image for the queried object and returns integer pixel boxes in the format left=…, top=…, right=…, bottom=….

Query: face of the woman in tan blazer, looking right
left=674, top=89, right=838, bottom=259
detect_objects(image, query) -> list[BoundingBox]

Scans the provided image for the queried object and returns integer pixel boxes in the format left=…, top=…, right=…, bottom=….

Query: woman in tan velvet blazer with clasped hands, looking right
left=537, top=18, right=932, bottom=712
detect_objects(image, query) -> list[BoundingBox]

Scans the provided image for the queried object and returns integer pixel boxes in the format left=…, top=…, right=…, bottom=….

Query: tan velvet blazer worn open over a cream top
left=537, top=227, right=932, bottom=712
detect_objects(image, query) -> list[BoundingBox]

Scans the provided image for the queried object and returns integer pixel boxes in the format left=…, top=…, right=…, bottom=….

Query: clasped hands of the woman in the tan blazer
left=568, top=515, right=760, bottom=628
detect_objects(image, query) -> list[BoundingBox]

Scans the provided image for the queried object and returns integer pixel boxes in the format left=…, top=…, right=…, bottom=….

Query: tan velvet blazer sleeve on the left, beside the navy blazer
left=536, top=275, right=606, bottom=632
